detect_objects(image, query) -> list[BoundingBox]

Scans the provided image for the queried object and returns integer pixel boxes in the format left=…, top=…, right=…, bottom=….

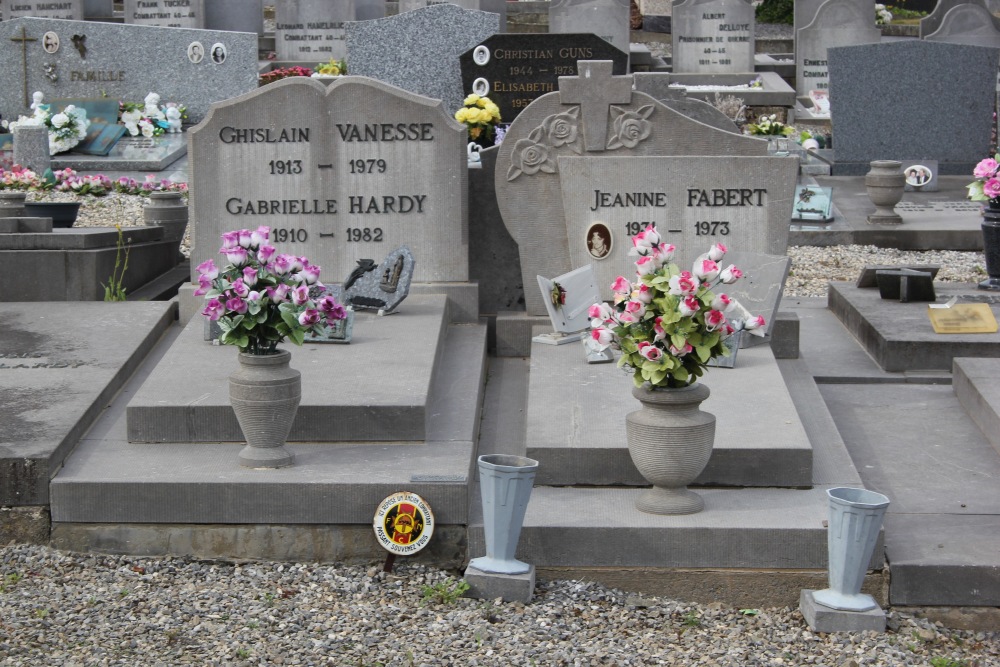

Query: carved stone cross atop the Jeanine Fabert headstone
left=559, top=60, right=632, bottom=151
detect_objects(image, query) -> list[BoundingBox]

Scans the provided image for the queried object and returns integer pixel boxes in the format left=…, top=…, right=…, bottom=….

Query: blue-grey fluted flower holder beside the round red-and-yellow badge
left=469, top=454, right=538, bottom=574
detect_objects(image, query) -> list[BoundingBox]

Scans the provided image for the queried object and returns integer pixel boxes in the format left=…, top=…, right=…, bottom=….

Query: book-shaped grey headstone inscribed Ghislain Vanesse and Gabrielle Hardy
left=188, top=76, right=469, bottom=282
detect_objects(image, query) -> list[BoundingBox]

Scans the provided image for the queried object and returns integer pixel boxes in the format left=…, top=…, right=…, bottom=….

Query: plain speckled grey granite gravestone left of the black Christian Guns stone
left=347, top=4, right=500, bottom=116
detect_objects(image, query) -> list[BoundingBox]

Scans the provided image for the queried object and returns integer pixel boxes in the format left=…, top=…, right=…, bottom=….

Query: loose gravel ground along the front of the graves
left=0, top=545, right=1000, bottom=667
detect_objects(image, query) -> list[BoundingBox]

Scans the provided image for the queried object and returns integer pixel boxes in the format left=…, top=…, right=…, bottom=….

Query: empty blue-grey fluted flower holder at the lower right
left=813, top=487, right=889, bottom=611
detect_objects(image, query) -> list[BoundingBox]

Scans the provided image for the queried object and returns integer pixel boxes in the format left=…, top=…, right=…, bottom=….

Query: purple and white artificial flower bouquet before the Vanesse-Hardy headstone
left=194, top=227, right=347, bottom=355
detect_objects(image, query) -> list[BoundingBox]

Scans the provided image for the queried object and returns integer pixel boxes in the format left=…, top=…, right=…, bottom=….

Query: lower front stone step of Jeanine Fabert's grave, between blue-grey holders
left=469, top=486, right=883, bottom=570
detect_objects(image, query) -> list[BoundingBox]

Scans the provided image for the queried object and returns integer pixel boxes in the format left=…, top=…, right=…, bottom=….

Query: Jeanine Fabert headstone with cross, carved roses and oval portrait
left=495, top=61, right=798, bottom=315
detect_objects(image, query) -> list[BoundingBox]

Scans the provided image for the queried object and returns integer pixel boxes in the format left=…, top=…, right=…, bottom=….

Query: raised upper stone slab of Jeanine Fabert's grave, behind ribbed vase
left=526, top=344, right=813, bottom=488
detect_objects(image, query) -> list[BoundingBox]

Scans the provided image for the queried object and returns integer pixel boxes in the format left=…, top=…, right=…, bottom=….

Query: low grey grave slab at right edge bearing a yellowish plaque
left=827, top=282, right=1000, bottom=371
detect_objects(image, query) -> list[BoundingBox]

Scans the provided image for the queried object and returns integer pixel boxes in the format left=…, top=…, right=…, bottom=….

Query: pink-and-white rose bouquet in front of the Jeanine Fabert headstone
left=590, top=225, right=766, bottom=387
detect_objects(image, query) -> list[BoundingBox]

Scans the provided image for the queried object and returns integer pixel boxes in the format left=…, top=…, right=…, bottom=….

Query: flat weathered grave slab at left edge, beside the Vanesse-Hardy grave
left=0, top=302, right=177, bottom=506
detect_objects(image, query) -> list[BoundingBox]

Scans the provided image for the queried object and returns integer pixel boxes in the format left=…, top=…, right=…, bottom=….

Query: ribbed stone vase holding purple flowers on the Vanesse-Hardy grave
left=229, top=350, right=302, bottom=468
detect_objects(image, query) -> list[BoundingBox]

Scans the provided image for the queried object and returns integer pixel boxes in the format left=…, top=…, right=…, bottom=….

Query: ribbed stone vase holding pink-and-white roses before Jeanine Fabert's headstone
left=625, top=383, right=715, bottom=514
